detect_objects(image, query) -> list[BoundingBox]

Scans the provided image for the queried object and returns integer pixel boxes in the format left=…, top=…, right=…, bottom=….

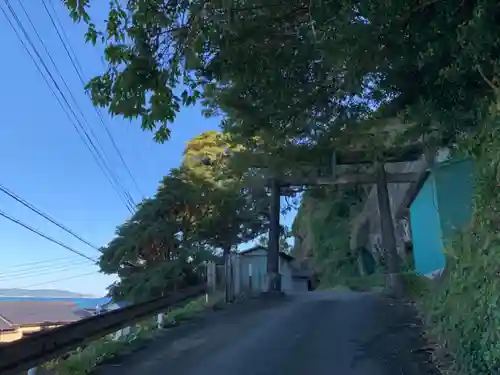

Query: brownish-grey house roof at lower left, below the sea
left=0, top=302, right=91, bottom=326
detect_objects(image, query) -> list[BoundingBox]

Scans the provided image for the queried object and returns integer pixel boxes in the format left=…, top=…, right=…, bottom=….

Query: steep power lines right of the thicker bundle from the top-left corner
left=41, top=0, right=144, bottom=197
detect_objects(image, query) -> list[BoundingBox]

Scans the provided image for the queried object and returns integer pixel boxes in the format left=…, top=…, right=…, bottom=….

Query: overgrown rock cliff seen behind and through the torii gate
left=293, top=118, right=432, bottom=280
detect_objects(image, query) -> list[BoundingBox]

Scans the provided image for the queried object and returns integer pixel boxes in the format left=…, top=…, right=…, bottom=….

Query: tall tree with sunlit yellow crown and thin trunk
left=183, top=131, right=268, bottom=300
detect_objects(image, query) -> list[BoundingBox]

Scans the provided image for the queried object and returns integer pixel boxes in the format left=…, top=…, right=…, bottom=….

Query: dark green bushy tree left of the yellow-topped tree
left=100, top=169, right=211, bottom=300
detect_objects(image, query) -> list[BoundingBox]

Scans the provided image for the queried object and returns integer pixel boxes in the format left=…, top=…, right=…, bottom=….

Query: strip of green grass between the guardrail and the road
left=41, top=293, right=224, bottom=375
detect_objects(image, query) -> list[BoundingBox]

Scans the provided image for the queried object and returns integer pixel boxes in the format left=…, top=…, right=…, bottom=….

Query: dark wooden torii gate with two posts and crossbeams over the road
left=267, top=144, right=424, bottom=294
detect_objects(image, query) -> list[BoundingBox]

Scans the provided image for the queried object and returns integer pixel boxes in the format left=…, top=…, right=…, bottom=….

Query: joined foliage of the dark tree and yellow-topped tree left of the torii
left=99, top=132, right=267, bottom=301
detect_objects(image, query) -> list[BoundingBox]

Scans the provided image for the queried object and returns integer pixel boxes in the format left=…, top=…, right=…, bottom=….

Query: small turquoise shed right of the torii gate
left=410, top=159, right=474, bottom=277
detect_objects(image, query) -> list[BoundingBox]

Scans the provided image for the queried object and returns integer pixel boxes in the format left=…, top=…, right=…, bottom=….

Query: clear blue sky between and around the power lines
left=0, top=0, right=293, bottom=295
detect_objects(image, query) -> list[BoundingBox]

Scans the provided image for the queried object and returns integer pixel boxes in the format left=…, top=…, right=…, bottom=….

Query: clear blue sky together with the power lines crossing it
left=0, top=0, right=291, bottom=295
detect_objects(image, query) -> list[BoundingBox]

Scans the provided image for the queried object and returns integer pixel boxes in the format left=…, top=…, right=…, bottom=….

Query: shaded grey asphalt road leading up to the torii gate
left=100, top=292, right=434, bottom=375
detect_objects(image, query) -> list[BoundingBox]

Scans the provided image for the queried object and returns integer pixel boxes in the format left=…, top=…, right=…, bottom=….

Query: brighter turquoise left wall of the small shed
left=410, top=175, right=446, bottom=275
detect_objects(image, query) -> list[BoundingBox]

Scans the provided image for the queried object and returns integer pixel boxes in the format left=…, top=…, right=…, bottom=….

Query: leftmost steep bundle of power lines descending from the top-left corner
left=0, top=0, right=135, bottom=214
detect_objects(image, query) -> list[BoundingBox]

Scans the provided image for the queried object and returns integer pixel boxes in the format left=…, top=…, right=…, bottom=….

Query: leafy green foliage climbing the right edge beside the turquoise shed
left=421, top=115, right=500, bottom=375
